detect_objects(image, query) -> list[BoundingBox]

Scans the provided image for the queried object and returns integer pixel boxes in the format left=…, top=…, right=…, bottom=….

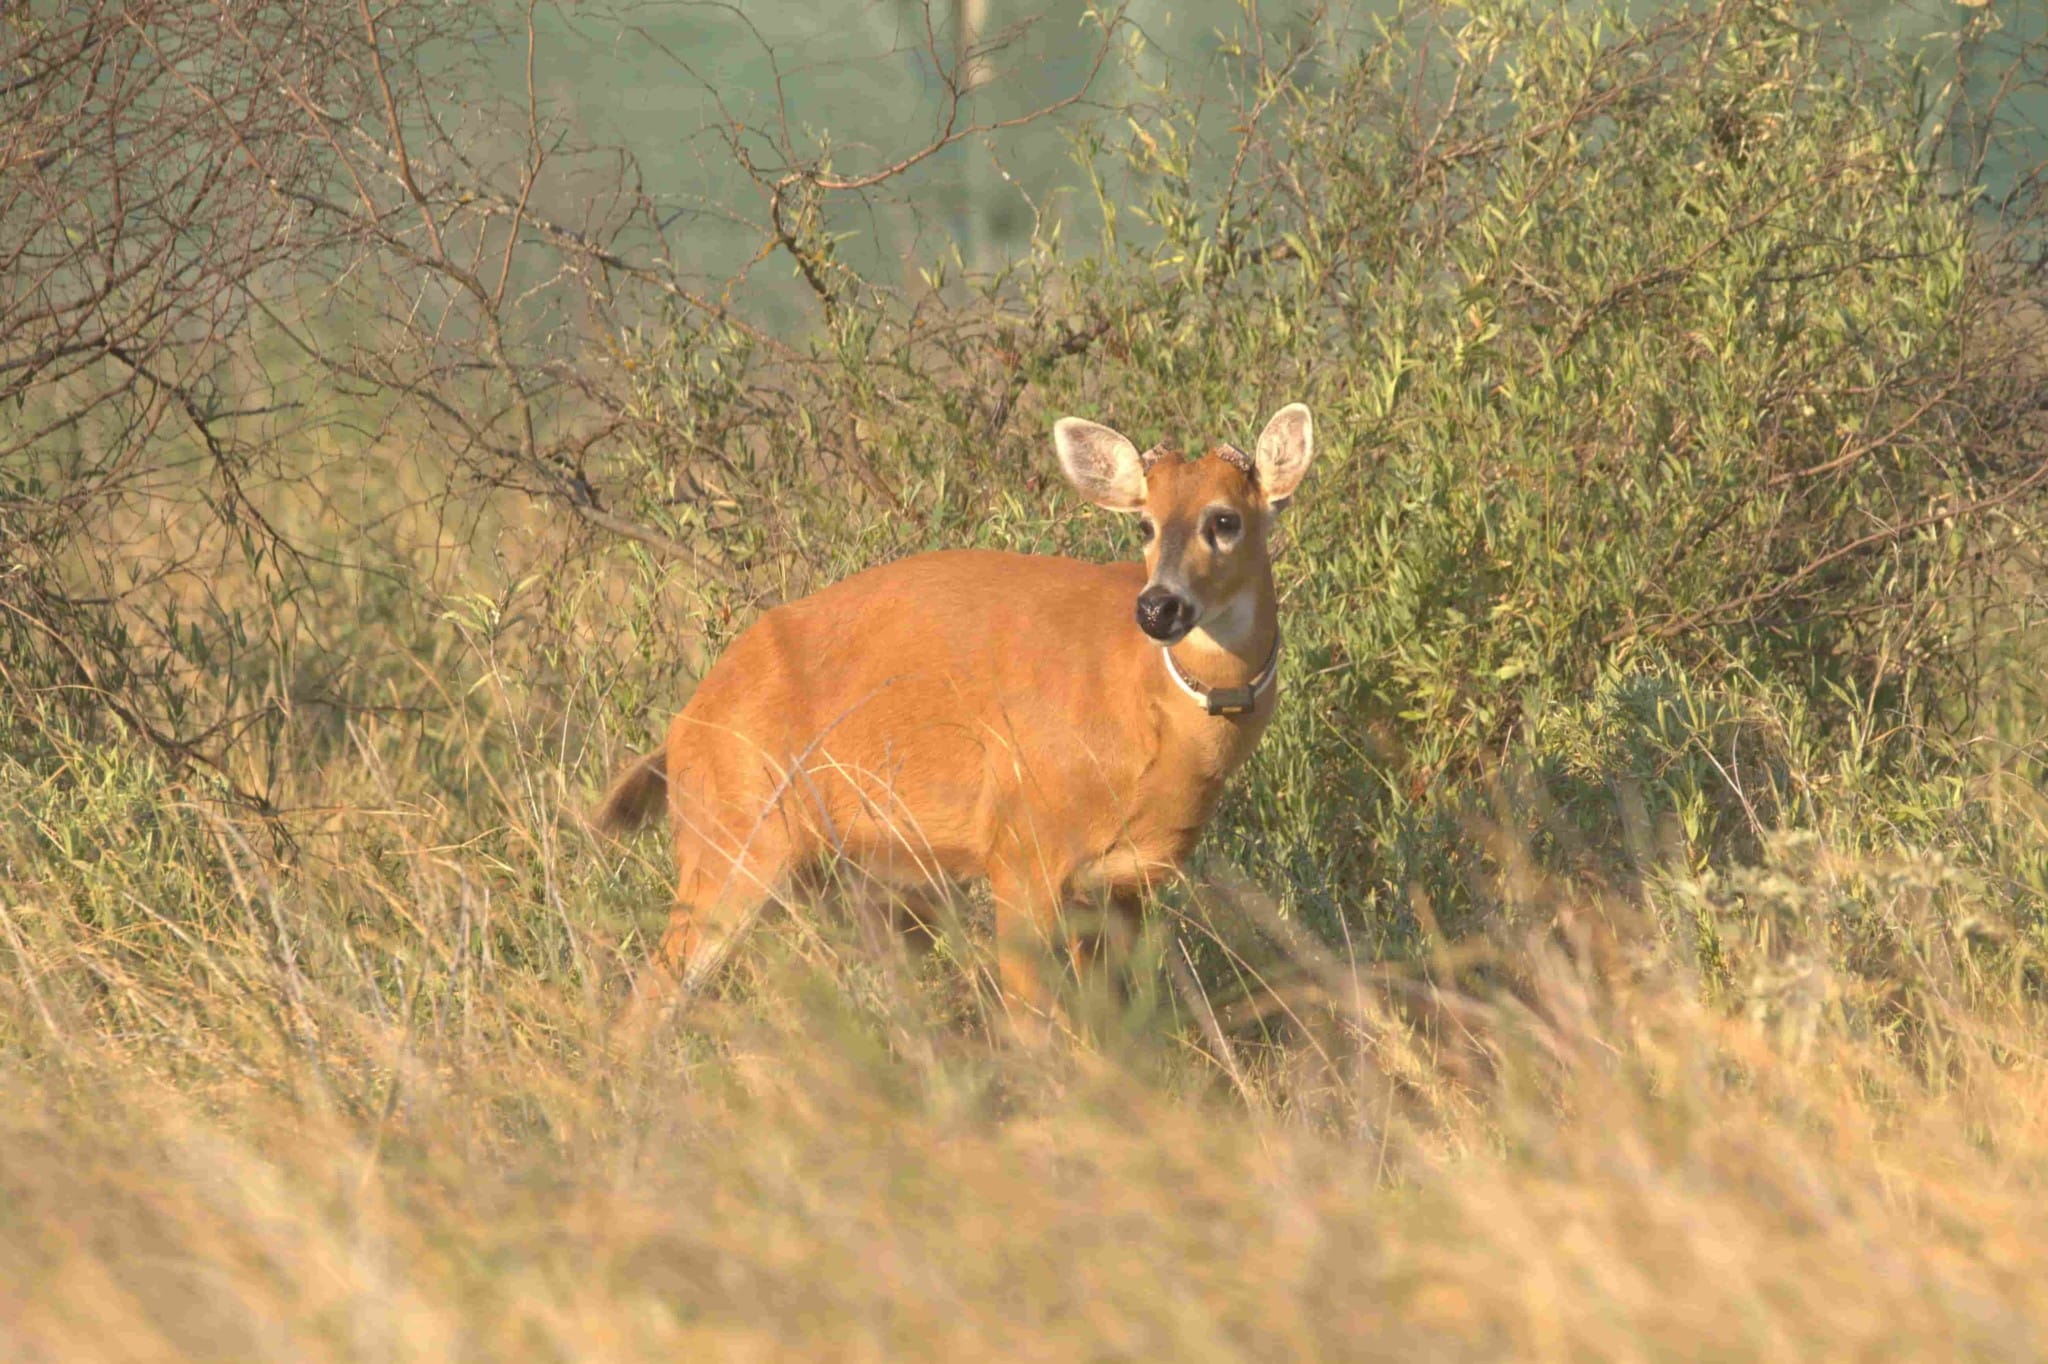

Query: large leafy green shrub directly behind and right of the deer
left=602, top=0, right=2040, bottom=948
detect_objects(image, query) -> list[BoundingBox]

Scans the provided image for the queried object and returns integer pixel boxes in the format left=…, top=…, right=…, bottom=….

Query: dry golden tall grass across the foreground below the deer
left=0, top=704, right=2048, bottom=1360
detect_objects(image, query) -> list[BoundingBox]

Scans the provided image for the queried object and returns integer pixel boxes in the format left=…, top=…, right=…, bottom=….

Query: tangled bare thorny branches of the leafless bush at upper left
left=0, top=0, right=1110, bottom=807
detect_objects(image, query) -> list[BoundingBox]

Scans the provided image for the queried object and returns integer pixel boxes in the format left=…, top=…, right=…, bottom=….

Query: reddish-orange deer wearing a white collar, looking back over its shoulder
left=594, top=403, right=1313, bottom=1008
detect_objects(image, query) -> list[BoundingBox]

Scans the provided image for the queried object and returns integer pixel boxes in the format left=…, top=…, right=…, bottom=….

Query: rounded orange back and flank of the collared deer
left=672, top=551, right=1159, bottom=875
